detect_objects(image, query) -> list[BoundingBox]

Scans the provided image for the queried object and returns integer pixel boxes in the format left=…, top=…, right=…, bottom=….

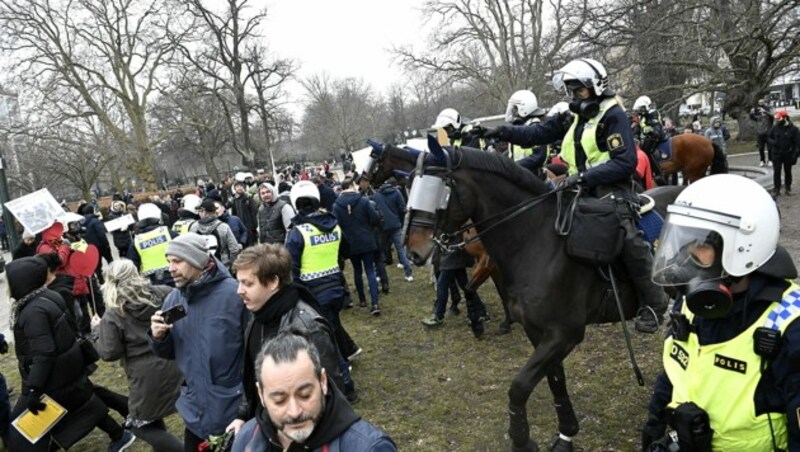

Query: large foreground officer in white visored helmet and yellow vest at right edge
left=642, top=174, right=800, bottom=451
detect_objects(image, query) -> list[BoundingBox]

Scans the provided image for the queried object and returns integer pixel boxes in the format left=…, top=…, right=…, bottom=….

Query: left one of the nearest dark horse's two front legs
left=508, top=326, right=585, bottom=452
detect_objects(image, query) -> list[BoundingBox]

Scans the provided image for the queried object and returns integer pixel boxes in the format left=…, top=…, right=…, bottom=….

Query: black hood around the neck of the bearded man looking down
left=256, top=377, right=361, bottom=450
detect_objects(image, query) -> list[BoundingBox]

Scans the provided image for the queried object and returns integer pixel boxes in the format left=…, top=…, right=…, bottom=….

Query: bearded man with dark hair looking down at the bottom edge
left=232, top=332, right=397, bottom=452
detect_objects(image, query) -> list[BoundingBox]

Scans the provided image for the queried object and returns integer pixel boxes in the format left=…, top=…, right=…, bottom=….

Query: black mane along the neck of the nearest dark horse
left=455, top=147, right=549, bottom=195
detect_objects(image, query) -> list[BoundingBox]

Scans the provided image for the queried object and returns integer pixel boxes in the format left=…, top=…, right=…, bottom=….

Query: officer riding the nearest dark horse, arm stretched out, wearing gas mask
left=484, top=58, right=667, bottom=333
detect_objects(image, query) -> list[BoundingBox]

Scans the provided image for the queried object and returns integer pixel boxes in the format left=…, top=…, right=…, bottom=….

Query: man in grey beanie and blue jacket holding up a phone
left=148, top=232, right=248, bottom=450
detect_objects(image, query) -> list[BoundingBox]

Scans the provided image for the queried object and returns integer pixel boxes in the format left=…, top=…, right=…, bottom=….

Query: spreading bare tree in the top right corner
left=581, top=0, right=800, bottom=140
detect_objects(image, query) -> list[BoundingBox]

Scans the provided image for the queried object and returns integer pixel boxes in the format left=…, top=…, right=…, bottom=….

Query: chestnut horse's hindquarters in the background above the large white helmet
left=642, top=133, right=728, bottom=185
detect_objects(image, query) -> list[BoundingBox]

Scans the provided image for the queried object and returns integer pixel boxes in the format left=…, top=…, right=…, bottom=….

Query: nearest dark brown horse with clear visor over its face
left=406, top=142, right=682, bottom=452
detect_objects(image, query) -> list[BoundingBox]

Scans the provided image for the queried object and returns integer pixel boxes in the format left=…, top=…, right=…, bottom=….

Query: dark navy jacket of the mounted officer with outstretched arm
left=500, top=105, right=637, bottom=188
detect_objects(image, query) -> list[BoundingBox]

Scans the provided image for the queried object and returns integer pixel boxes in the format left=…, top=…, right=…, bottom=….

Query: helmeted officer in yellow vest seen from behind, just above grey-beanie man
left=128, top=204, right=177, bottom=286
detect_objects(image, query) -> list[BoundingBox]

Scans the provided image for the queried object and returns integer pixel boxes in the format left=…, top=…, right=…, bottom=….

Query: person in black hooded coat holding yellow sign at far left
left=6, top=257, right=136, bottom=452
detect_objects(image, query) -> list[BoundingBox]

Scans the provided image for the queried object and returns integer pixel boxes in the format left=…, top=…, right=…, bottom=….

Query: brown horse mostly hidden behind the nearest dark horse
left=362, top=140, right=513, bottom=334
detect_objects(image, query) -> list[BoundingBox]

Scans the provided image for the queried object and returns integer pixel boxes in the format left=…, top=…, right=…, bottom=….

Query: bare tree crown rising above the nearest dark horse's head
left=395, top=0, right=588, bottom=109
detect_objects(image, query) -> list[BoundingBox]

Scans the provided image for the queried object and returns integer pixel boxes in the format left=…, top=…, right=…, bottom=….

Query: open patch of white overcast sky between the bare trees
left=264, top=0, right=427, bottom=110
